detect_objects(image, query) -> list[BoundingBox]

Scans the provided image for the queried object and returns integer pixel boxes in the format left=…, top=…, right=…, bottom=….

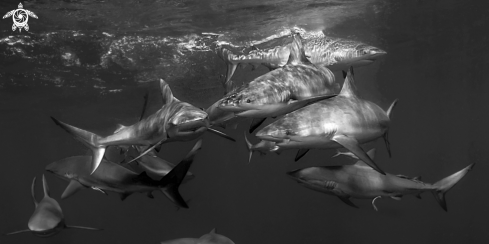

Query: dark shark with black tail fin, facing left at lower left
left=46, top=140, right=202, bottom=208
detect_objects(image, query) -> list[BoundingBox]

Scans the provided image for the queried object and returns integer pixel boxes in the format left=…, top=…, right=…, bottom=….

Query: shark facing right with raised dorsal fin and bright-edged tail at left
left=51, top=79, right=234, bottom=173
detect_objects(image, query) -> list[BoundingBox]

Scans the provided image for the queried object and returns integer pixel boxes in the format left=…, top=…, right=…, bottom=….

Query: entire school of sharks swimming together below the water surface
left=0, top=28, right=474, bottom=244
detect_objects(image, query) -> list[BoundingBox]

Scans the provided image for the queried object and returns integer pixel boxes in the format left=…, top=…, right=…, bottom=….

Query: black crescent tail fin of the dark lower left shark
left=158, top=140, right=202, bottom=208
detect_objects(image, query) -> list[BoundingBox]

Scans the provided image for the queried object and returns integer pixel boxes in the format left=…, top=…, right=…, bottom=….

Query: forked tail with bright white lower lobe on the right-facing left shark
left=51, top=117, right=107, bottom=174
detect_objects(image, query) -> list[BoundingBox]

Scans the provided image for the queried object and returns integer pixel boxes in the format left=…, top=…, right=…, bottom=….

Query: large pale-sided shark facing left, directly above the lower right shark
left=252, top=67, right=397, bottom=174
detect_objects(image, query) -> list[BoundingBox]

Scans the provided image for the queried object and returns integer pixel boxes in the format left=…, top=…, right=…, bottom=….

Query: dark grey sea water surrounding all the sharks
left=0, top=0, right=489, bottom=244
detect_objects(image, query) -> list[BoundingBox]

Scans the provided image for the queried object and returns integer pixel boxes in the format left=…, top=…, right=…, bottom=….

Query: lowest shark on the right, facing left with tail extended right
left=287, top=149, right=474, bottom=211
